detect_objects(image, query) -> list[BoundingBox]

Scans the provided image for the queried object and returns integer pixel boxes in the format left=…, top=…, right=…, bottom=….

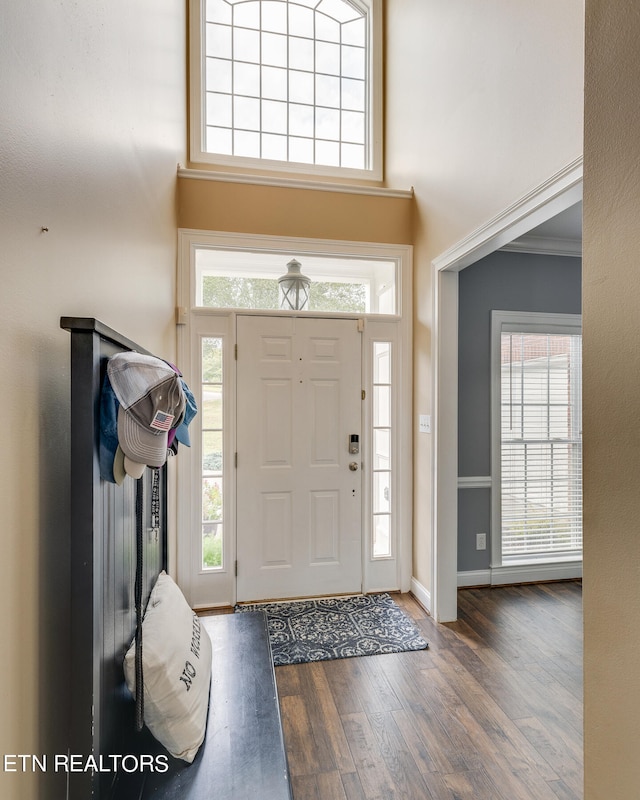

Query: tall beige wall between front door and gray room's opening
left=386, top=0, right=583, bottom=590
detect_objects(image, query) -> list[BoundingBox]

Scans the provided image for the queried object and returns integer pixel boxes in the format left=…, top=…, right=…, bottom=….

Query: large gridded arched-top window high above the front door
left=191, top=0, right=381, bottom=179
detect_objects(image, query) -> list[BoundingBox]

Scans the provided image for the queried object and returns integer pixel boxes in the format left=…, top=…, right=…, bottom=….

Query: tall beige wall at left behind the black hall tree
left=0, top=0, right=185, bottom=800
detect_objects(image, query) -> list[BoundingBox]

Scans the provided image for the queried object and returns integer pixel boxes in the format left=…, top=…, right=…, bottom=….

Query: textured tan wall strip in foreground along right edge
left=583, top=0, right=640, bottom=800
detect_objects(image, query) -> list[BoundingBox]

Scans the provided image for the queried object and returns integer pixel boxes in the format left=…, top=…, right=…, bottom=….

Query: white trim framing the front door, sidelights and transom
left=176, top=229, right=413, bottom=608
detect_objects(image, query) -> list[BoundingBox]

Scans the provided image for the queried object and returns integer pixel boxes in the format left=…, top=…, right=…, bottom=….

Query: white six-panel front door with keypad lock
left=237, top=316, right=362, bottom=601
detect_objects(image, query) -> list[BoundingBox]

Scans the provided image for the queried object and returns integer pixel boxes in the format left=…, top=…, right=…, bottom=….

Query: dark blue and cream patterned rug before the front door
left=235, top=594, right=428, bottom=666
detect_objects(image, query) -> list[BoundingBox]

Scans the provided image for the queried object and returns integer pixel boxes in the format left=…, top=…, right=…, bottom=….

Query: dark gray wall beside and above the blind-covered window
left=458, top=251, right=582, bottom=572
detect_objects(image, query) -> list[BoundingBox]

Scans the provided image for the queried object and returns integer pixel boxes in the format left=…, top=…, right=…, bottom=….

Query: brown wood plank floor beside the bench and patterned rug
left=276, top=582, right=582, bottom=800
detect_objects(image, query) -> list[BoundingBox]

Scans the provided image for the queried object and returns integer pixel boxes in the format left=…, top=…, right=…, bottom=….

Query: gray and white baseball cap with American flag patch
left=107, top=352, right=185, bottom=477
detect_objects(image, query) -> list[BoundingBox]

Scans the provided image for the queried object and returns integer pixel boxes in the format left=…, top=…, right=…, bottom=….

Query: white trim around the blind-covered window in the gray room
left=490, top=311, right=582, bottom=585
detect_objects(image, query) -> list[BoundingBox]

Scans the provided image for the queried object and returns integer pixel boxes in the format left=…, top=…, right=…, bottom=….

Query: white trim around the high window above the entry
left=189, top=0, right=383, bottom=181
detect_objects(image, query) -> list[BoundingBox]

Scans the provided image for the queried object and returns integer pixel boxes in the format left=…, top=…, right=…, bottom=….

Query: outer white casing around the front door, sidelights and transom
left=172, top=229, right=413, bottom=608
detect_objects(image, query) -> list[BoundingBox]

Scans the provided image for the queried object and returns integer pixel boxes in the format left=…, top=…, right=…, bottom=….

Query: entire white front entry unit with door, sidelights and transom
left=176, top=231, right=412, bottom=608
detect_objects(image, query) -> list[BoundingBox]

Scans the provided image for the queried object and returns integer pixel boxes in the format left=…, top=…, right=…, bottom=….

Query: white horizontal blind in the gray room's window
left=501, top=332, right=582, bottom=560
